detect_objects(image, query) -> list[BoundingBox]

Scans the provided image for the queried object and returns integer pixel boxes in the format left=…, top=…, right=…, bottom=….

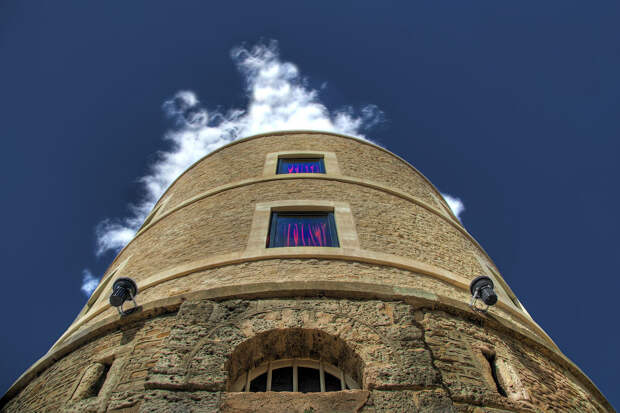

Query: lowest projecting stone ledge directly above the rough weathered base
left=0, top=276, right=605, bottom=406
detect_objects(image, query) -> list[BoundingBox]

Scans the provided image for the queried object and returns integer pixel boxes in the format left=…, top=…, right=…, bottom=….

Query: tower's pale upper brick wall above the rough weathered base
left=59, top=133, right=553, bottom=345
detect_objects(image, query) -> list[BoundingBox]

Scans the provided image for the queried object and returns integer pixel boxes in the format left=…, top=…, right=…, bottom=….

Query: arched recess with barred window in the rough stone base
left=228, top=328, right=362, bottom=393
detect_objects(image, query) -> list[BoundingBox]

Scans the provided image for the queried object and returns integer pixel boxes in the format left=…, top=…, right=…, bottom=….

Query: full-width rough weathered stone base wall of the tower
left=3, top=297, right=613, bottom=413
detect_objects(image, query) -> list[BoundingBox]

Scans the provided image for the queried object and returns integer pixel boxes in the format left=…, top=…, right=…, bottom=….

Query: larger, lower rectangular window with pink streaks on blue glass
left=267, top=212, right=340, bottom=248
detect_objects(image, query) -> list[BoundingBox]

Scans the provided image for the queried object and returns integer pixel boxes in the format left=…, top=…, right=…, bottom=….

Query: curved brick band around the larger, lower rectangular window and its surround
left=117, top=179, right=482, bottom=281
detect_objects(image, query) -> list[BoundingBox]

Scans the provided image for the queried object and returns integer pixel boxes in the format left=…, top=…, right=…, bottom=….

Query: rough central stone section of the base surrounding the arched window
left=147, top=299, right=439, bottom=391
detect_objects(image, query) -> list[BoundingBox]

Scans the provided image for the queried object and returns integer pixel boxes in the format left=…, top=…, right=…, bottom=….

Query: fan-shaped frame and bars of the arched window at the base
left=230, top=358, right=360, bottom=393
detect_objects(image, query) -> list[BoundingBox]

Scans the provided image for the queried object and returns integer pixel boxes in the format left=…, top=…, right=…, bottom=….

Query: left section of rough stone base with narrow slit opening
left=2, top=314, right=175, bottom=413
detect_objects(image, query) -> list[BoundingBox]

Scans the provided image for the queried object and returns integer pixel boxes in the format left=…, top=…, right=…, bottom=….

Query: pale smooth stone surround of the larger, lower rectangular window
left=246, top=199, right=360, bottom=255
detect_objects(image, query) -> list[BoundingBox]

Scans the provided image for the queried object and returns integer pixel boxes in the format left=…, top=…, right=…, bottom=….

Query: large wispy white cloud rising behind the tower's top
left=96, top=41, right=382, bottom=255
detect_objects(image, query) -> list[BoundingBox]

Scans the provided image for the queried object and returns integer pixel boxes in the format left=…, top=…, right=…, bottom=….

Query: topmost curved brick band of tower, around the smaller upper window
left=150, top=132, right=448, bottom=213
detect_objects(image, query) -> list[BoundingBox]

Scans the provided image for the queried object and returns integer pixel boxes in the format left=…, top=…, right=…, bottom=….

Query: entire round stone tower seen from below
left=1, top=131, right=613, bottom=413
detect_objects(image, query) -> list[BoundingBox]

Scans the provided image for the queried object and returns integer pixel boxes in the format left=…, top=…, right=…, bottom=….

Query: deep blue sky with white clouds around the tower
left=0, top=0, right=620, bottom=408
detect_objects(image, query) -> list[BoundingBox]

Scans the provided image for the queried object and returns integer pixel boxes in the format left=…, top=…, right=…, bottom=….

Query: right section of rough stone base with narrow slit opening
left=416, top=311, right=606, bottom=412
